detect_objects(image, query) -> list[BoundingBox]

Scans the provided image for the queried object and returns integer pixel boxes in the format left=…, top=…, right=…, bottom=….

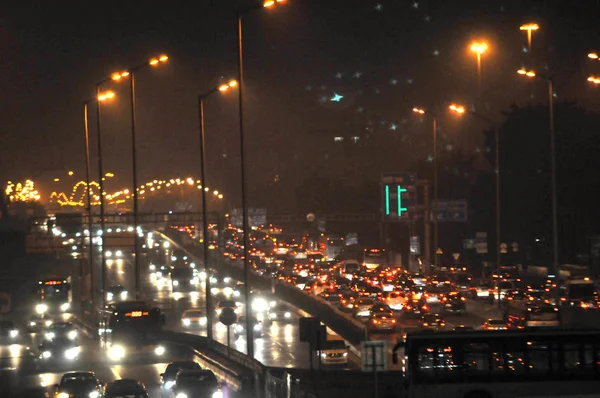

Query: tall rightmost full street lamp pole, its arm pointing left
left=517, top=69, right=560, bottom=294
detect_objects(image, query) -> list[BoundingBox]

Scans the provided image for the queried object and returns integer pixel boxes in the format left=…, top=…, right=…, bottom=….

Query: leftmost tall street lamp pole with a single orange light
left=83, top=91, right=115, bottom=309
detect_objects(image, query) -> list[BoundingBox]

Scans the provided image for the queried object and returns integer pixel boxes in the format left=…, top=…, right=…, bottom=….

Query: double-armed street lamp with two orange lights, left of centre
left=101, top=54, right=169, bottom=299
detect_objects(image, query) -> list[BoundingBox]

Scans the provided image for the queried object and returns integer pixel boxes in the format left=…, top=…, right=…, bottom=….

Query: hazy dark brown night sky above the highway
left=0, top=0, right=600, bottom=208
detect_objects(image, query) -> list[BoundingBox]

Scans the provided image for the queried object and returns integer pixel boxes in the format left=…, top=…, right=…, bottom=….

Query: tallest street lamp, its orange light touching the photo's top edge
left=237, top=0, right=286, bottom=358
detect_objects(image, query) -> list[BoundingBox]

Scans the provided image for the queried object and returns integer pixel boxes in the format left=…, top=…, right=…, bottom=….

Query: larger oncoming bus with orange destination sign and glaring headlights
left=98, top=301, right=165, bottom=361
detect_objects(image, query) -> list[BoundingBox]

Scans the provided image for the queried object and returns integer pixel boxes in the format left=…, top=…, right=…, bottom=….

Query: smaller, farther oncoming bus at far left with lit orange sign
left=35, top=277, right=71, bottom=315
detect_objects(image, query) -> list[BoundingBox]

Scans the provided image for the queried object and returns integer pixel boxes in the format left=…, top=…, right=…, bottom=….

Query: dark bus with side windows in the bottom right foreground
left=392, top=330, right=600, bottom=398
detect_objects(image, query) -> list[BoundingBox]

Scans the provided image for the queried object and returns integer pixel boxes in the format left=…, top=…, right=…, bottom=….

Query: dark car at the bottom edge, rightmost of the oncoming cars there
left=172, top=369, right=223, bottom=398
